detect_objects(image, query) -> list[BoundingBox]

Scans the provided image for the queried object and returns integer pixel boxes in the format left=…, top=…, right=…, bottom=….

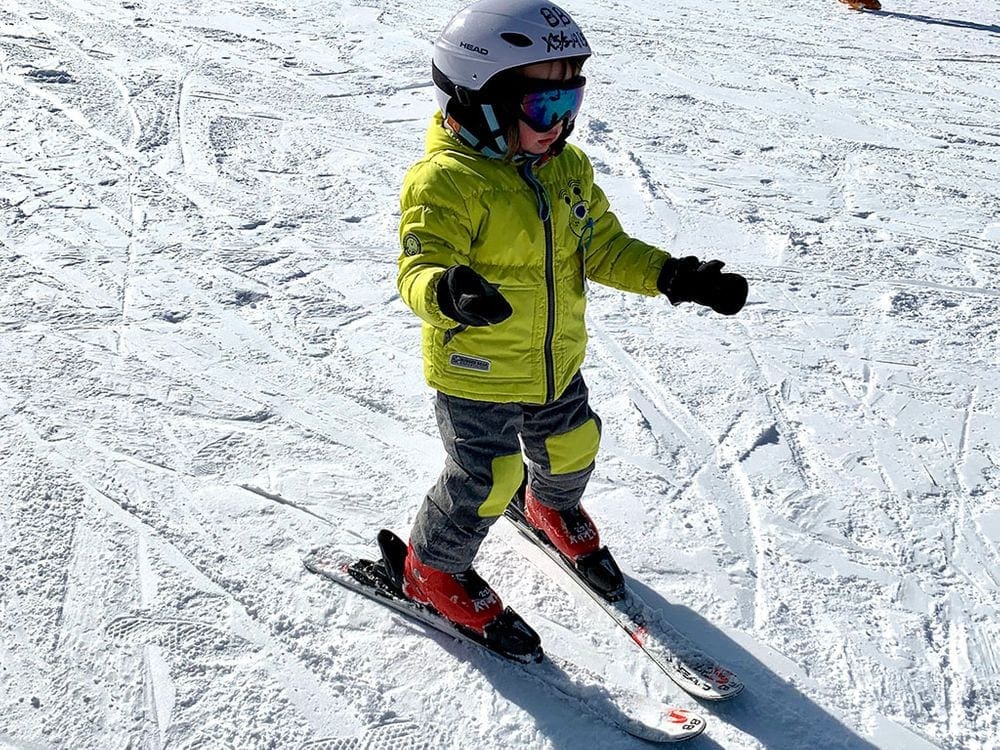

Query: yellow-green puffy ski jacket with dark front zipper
left=397, top=112, right=669, bottom=404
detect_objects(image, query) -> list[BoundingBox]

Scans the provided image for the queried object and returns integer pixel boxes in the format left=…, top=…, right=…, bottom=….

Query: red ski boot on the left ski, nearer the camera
left=403, top=545, right=504, bottom=635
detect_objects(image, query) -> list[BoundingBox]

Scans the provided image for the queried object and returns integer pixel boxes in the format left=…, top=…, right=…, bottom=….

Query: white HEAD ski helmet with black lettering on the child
left=432, top=0, right=591, bottom=156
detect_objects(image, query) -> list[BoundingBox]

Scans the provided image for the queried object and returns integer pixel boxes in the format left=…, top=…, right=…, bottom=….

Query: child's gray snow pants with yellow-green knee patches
left=410, top=373, right=601, bottom=573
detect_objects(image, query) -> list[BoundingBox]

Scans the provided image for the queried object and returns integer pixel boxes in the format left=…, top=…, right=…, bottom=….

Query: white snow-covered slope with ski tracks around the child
left=0, top=0, right=1000, bottom=750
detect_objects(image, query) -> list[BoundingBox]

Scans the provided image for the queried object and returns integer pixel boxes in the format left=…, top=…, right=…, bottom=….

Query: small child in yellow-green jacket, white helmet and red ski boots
left=398, top=0, right=747, bottom=648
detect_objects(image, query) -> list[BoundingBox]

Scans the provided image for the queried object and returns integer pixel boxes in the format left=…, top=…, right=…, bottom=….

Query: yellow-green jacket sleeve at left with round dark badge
left=396, top=161, right=473, bottom=329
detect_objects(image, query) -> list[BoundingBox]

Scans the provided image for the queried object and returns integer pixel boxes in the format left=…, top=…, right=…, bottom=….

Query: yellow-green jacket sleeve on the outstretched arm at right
left=585, top=184, right=670, bottom=297
